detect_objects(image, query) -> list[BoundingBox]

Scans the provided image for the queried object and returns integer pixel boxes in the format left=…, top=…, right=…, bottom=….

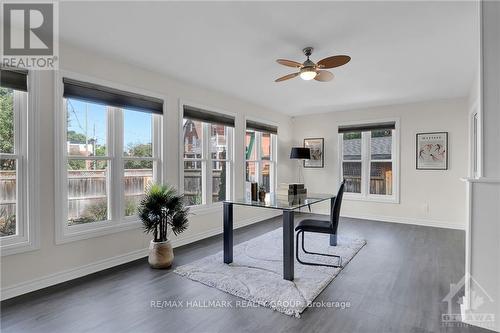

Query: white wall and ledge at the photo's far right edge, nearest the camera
left=462, top=1, right=500, bottom=332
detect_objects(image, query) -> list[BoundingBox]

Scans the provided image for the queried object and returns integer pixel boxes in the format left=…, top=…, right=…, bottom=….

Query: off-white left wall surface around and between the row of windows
left=1, top=45, right=295, bottom=298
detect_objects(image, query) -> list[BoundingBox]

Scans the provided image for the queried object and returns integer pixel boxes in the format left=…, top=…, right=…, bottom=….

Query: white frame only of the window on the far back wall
left=338, top=118, right=400, bottom=204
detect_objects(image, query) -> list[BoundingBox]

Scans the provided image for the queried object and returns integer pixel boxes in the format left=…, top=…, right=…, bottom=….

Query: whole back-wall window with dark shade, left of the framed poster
left=339, top=122, right=399, bottom=201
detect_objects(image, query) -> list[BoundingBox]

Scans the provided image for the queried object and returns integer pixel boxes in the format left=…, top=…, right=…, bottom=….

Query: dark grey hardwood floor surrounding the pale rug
left=1, top=214, right=487, bottom=333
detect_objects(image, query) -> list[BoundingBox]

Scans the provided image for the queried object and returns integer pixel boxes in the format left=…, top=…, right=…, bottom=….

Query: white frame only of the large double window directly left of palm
left=54, top=71, right=167, bottom=244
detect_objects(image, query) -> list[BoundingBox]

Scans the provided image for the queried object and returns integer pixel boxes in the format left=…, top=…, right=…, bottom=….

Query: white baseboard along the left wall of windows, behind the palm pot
left=0, top=212, right=281, bottom=301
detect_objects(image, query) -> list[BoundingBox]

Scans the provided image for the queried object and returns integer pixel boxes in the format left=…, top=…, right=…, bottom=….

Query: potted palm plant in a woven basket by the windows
left=137, top=184, right=189, bottom=268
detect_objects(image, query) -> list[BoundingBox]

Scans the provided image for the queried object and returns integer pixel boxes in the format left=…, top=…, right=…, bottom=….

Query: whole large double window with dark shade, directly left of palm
left=57, top=78, right=163, bottom=242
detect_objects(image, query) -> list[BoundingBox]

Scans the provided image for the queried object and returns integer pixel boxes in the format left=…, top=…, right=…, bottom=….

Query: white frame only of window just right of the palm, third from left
left=178, top=100, right=236, bottom=214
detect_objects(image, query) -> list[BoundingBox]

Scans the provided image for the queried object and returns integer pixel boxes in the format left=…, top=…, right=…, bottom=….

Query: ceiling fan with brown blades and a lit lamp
left=274, top=47, right=351, bottom=82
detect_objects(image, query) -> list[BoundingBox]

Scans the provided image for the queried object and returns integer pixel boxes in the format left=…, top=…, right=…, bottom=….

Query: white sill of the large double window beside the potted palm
left=56, top=218, right=141, bottom=244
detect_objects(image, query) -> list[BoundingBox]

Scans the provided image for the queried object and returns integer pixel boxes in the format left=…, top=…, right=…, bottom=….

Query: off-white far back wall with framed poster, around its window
left=293, top=98, right=468, bottom=228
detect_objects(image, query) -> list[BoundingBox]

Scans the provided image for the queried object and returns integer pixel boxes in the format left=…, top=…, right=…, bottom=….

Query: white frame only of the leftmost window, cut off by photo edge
left=0, top=71, right=40, bottom=256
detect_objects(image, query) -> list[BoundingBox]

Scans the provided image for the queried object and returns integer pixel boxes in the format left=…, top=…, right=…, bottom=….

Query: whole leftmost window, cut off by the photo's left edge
left=0, top=68, right=38, bottom=255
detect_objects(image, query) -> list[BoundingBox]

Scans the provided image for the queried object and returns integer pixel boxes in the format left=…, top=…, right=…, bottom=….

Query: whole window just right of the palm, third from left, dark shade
left=181, top=105, right=234, bottom=206
